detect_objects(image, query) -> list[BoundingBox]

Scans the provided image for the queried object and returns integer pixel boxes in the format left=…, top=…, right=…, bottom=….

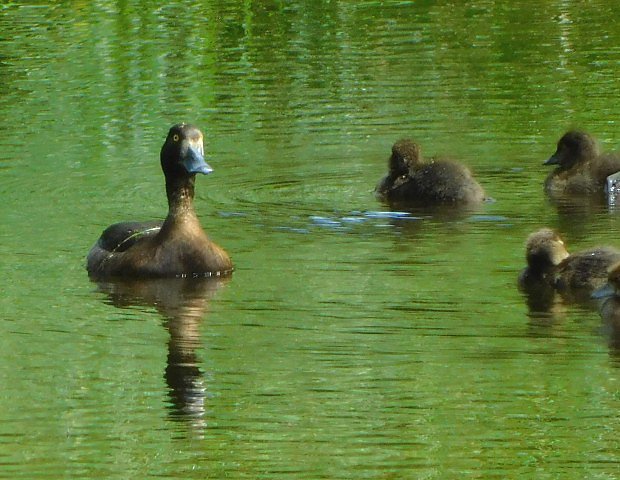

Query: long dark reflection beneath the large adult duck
left=97, top=278, right=229, bottom=429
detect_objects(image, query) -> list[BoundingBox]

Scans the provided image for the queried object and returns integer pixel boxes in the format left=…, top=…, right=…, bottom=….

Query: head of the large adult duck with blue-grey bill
left=160, top=123, right=213, bottom=178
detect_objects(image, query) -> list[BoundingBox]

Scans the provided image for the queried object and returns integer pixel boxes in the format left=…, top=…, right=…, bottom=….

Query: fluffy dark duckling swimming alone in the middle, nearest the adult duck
left=375, top=139, right=485, bottom=205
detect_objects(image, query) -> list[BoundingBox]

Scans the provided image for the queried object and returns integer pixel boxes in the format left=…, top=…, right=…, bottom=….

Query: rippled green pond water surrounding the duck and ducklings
left=0, top=0, right=620, bottom=479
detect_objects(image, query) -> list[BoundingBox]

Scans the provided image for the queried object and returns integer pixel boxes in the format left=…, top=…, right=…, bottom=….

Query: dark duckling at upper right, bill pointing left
left=544, top=130, right=620, bottom=196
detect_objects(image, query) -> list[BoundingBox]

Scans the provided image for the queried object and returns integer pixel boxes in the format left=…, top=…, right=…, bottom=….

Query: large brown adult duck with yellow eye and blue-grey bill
left=86, top=123, right=233, bottom=279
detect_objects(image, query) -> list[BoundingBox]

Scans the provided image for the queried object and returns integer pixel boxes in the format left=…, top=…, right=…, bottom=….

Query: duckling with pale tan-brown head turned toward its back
left=519, top=228, right=620, bottom=300
